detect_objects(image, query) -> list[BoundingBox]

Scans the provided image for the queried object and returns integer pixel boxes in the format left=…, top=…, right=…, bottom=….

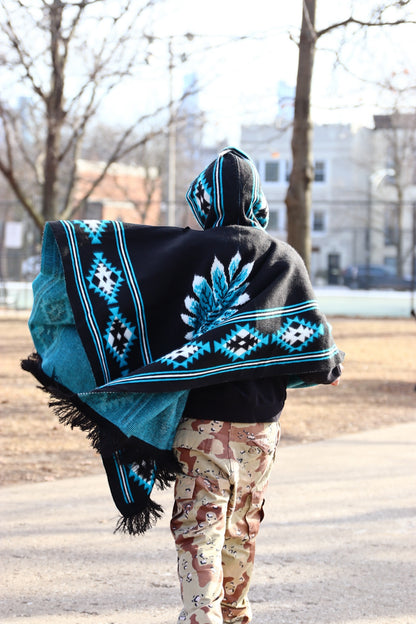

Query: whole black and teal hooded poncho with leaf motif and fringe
left=22, top=148, right=343, bottom=533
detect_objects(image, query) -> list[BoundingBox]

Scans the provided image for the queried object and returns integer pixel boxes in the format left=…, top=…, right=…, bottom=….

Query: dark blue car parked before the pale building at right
left=342, top=264, right=412, bottom=290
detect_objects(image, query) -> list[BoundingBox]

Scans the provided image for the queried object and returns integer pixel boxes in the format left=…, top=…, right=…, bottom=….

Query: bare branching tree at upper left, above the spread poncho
left=0, top=0, right=174, bottom=231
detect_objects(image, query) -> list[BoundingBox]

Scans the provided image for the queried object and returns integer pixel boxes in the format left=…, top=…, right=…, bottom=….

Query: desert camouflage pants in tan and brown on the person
left=171, top=419, right=280, bottom=624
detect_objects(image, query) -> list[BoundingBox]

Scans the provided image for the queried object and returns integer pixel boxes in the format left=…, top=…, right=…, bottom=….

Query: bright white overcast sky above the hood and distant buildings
left=55, top=0, right=416, bottom=144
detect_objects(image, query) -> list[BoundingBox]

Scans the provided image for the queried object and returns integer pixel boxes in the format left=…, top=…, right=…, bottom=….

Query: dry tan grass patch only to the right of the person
left=282, top=318, right=416, bottom=442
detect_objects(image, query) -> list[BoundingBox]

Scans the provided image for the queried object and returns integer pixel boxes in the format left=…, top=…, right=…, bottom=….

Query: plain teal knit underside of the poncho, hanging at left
left=29, top=223, right=189, bottom=450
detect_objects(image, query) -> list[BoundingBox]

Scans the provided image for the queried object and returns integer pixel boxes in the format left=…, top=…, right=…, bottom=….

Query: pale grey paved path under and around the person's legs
left=0, top=422, right=416, bottom=624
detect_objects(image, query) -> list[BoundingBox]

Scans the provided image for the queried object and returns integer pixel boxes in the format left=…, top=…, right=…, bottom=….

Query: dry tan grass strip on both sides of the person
left=0, top=317, right=416, bottom=485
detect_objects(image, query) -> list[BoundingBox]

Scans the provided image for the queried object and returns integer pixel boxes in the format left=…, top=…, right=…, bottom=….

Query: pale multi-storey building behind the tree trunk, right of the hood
left=241, top=119, right=416, bottom=284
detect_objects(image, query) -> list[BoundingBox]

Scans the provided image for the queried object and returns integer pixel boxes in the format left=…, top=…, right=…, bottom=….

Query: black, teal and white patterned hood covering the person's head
left=186, top=147, right=269, bottom=230
